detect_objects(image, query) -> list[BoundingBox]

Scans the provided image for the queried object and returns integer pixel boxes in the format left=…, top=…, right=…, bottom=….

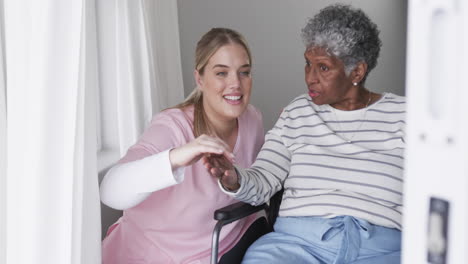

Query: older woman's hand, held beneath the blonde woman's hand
left=202, top=154, right=240, bottom=191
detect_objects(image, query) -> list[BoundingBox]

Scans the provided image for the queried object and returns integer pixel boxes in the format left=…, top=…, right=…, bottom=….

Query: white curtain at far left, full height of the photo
left=4, top=0, right=101, bottom=264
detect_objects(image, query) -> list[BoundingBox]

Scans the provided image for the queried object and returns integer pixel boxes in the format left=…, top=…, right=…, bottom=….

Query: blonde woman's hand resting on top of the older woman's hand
left=169, top=135, right=234, bottom=170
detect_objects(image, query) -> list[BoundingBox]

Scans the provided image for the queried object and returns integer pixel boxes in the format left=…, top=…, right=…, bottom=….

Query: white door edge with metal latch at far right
left=402, top=0, right=468, bottom=264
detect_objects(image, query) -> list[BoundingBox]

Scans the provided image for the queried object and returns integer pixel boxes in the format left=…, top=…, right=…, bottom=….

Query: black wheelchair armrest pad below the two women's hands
left=214, top=202, right=268, bottom=223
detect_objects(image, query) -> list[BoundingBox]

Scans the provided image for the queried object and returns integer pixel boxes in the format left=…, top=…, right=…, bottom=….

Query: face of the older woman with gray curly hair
left=304, top=48, right=352, bottom=105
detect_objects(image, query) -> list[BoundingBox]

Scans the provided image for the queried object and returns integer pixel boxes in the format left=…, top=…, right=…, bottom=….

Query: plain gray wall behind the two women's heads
left=177, top=0, right=407, bottom=130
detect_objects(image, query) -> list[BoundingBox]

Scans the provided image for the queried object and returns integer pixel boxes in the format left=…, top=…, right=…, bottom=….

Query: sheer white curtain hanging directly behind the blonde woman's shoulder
left=111, top=0, right=183, bottom=155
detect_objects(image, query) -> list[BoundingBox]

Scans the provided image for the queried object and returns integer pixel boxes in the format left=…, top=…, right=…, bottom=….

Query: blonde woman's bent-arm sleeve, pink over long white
left=100, top=110, right=192, bottom=210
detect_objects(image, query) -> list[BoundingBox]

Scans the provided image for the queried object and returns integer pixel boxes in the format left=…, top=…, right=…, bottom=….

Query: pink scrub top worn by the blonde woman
left=102, top=105, right=264, bottom=264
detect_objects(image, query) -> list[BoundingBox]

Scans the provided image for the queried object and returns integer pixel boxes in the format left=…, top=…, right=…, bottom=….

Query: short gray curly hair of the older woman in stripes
left=301, top=4, right=382, bottom=82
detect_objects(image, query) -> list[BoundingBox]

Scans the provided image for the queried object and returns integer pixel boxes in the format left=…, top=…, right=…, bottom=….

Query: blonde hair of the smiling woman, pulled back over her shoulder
left=173, top=28, right=252, bottom=137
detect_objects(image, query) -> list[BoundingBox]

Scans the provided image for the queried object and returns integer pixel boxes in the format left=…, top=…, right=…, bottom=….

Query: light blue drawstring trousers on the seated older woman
left=242, top=216, right=401, bottom=264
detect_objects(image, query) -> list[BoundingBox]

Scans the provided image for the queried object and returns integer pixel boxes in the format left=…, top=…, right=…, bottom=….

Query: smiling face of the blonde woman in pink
left=195, top=44, right=252, bottom=124
